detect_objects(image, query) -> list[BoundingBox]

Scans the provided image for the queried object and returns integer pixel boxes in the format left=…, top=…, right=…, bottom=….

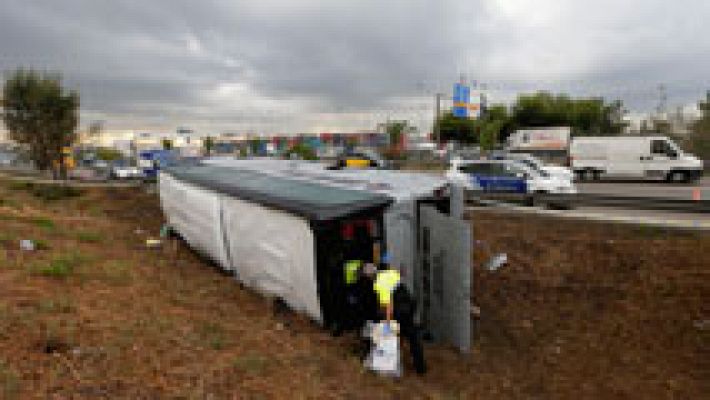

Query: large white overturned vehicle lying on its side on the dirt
left=159, top=158, right=471, bottom=351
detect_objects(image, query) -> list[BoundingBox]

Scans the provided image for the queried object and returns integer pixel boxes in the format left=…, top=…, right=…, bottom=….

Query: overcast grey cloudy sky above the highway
left=0, top=0, right=710, bottom=133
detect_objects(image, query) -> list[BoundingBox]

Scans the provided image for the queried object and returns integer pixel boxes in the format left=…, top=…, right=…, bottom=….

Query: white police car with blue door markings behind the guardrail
left=446, top=158, right=577, bottom=203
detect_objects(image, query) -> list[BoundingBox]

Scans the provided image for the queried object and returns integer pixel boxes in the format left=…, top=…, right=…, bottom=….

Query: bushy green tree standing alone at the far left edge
left=2, top=69, right=79, bottom=178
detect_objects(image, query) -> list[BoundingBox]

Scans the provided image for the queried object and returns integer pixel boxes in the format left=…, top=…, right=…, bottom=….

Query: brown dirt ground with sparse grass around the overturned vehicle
left=0, top=181, right=710, bottom=399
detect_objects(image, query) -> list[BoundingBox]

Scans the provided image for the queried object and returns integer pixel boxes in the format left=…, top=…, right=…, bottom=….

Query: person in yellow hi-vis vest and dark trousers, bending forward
left=373, top=255, right=427, bottom=375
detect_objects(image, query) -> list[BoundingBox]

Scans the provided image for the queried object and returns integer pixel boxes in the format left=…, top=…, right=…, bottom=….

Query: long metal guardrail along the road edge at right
left=466, top=192, right=710, bottom=213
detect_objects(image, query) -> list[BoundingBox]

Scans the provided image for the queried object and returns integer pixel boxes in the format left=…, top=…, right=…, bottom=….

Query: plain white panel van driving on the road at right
left=570, top=136, right=703, bottom=182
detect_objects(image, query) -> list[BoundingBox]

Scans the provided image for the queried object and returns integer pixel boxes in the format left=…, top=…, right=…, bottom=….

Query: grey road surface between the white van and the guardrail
left=577, top=176, right=710, bottom=200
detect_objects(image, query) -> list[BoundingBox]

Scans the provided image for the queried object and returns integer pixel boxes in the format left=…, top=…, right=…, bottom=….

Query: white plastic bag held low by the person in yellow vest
left=365, top=321, right=402, bottom=377
